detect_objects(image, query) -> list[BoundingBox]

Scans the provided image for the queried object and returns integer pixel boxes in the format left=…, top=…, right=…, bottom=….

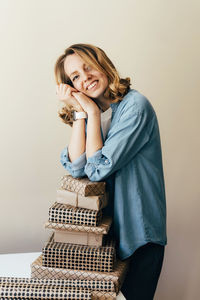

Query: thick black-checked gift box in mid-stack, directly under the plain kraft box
left=42, top=234, right=116, bottom=272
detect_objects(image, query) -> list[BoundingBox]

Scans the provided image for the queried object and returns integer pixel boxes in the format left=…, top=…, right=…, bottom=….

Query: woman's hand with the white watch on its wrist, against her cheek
left=56, top=83, right=84, bottom=111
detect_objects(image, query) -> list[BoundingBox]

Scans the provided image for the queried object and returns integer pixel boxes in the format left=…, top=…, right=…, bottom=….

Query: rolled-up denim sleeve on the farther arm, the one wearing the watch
left=60, top=147, right=87, bottom=178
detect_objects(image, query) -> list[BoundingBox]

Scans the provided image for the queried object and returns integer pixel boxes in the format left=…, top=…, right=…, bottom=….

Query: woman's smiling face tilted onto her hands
left=64, top=53, right=108, bottom=99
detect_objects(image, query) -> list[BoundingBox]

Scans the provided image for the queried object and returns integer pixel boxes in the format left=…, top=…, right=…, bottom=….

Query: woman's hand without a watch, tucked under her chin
left=72, top=91, right=100, bottom=115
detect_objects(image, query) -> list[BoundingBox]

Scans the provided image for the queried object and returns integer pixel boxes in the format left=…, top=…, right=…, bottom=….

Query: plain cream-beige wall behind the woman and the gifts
left=0, top=0, right=200, bottom=300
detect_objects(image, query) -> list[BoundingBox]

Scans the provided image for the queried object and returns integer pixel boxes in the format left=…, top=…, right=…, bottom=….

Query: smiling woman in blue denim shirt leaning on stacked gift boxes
left=55, top=44, right=167, bottom=300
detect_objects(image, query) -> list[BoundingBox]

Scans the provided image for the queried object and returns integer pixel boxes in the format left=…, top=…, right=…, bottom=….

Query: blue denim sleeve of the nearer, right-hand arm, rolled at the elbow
left=84, top=109, right=154, bottom=181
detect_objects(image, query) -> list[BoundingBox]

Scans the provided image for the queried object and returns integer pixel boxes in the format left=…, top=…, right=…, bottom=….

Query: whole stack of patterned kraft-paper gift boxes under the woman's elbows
left=0, top=175, right=128, bottom=300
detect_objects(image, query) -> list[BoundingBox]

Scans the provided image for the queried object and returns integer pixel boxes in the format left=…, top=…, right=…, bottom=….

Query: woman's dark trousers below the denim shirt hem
left=121, top=243, right=165, bottom=300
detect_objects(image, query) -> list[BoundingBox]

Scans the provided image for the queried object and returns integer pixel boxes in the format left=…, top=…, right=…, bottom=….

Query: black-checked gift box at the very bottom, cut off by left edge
left=0, top=277, right=116, bottom=300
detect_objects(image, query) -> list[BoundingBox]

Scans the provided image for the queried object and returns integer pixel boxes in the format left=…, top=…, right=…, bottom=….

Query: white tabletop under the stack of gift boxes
left=0, top=252, right=126, bottom=300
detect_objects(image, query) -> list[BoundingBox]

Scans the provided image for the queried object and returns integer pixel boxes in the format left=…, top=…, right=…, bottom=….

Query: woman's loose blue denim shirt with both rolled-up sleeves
left=61, top=89, right=167, bottom=260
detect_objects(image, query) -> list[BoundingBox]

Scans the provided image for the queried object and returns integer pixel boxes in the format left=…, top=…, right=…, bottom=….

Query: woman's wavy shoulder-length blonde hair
left=54, top=44, right=131, bottom=126
